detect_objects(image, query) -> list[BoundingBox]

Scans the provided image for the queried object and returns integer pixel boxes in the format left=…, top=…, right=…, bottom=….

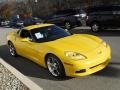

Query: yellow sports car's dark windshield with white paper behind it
left=31, top=25, right=70, bottom=43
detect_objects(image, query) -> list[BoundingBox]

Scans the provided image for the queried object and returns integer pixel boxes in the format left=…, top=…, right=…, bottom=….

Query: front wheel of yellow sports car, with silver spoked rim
left=46, top=54, right=65, bottom=78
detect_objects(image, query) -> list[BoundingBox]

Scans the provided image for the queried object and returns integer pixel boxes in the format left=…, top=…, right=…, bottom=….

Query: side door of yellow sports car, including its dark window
left=15, top=30, right=38, bottom=61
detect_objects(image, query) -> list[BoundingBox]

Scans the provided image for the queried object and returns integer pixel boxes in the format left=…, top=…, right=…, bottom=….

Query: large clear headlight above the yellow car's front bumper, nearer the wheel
left=65, top=51, right=86, bottom=60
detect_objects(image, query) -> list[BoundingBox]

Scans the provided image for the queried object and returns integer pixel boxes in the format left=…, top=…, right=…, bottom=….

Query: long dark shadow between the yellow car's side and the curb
left=0, top=45, right=71, bottom=81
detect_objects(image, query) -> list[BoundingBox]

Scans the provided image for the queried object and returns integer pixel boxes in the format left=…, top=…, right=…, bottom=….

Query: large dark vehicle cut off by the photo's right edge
left=86, top=5, right=120, bottom=32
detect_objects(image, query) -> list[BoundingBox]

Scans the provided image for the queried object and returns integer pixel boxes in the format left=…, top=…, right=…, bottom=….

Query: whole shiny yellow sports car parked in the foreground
left=7, top=24, right=111, bottom=77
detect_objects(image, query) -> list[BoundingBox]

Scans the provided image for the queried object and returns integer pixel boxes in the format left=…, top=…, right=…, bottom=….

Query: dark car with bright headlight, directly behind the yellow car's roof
left=45, top=9, right=86, bottom=29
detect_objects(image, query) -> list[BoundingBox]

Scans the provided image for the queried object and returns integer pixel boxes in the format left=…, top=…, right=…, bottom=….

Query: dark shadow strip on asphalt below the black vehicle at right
left=70, top=28, right=120, bottom=37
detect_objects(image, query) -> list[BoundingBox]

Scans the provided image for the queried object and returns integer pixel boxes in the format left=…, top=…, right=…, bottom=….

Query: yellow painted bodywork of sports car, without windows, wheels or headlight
left=7, top=24, right=111, bottom=76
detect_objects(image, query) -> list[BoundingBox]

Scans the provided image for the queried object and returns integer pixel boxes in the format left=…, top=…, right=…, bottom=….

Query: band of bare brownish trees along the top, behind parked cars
left=0, top=0, right=120, bottom=17
